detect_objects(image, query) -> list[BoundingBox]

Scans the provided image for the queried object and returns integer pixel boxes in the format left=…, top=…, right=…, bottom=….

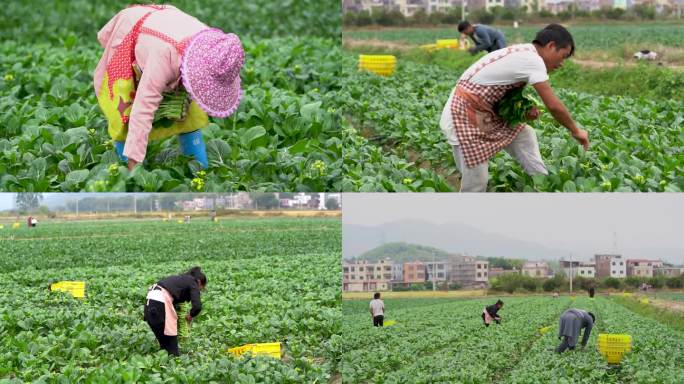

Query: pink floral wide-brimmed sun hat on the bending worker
left=181, top=28, right=245, bottom=118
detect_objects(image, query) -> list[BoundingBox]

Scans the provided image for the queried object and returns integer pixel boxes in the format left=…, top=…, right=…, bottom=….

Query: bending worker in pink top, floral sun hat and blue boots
left=93, top=5, right=244, bottom=169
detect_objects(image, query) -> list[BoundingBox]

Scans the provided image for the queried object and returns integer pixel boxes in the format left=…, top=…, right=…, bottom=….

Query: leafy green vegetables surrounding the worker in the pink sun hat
left=0, top=0, right=343, bottom=192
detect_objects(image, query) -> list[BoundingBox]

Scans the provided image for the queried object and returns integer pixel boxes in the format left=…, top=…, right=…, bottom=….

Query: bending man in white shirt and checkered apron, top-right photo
left=440, top=24, right=589, bottom=192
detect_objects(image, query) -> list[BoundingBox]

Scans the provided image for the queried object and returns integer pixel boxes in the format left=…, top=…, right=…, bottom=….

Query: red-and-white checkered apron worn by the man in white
left=451, top=47, right=529, bottom=168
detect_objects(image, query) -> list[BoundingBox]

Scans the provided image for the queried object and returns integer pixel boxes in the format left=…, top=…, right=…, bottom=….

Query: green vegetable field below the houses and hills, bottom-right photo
left=341, top=297, right=684, bottom=384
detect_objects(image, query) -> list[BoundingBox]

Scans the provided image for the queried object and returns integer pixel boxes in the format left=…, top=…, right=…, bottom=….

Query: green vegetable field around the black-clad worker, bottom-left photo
left=0, top=218, right=341, bottom=383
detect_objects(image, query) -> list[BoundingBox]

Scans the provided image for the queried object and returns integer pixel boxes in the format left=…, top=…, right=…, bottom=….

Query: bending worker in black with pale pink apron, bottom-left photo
left=145, top=267, right=207, bottom=356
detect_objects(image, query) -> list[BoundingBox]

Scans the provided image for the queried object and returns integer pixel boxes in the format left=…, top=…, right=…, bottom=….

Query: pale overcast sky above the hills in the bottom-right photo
left=342, top=193, right=684, bottom=263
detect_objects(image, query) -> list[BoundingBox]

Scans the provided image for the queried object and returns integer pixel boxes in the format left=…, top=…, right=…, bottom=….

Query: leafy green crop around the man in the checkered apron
left=339, top=55, right=684, bottom=192
